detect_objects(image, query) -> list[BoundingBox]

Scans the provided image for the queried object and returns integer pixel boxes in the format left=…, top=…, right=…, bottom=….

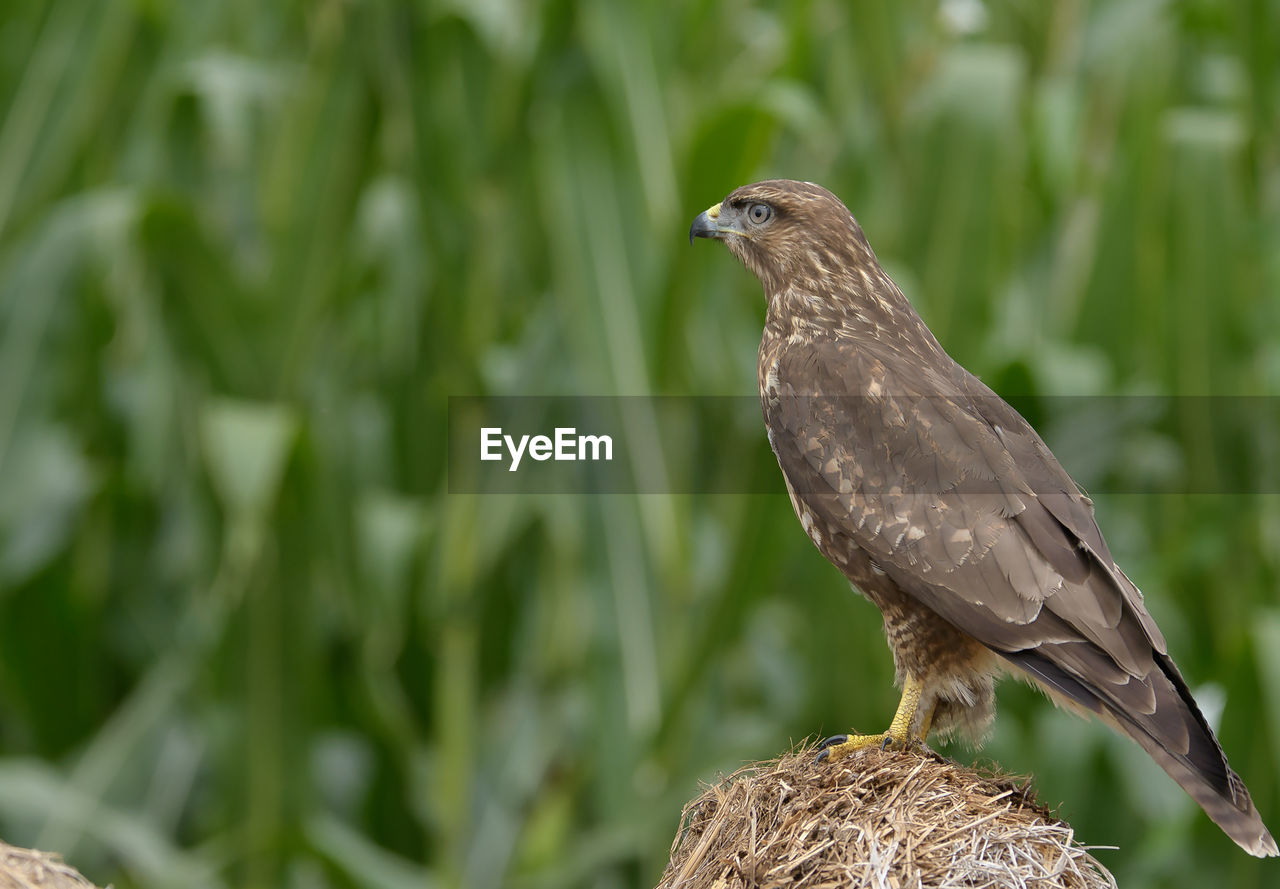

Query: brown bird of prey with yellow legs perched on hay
left=689, top=179, right=1277, bottom=856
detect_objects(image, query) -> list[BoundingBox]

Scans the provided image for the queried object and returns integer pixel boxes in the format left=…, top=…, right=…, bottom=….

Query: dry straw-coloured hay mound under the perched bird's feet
left=658, top=746, right=1116, bottom=889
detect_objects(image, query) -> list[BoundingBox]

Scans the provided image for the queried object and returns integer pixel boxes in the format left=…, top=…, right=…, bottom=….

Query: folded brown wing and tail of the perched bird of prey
left=764, top=342, right=1276, bottom=854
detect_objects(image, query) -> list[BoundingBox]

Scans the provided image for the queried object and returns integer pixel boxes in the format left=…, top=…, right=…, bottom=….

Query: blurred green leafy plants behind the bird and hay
left=0, top=0, right=1280, bottom=889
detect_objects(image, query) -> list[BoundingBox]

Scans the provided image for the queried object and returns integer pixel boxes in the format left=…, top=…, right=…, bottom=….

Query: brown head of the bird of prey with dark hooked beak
left=689, top=179, right=878, bottom=295
